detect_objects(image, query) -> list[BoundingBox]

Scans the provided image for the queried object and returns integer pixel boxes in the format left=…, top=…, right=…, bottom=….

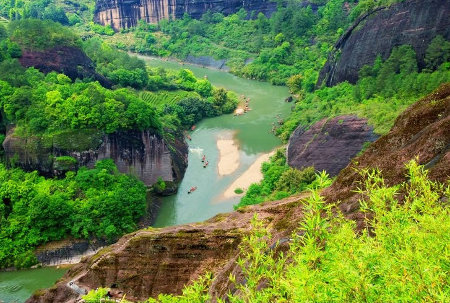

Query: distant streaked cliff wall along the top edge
left=95, top=0, right=276, bottom=30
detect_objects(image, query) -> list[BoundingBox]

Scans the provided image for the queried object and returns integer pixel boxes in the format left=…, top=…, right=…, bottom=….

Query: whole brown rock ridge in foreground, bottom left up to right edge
left=27, top=84, right=450, bottom=303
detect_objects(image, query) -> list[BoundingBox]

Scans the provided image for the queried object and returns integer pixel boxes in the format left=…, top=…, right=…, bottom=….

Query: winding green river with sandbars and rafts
left=0, top=56, right=291, bottom=303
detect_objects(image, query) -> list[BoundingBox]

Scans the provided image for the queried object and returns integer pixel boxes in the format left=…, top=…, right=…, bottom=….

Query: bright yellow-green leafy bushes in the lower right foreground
left=84, top=161, right=450, bottom=303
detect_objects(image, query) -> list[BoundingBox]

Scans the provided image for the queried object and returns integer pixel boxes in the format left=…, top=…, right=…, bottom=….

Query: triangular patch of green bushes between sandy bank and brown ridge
left=235, top=149, right=331, bottom=209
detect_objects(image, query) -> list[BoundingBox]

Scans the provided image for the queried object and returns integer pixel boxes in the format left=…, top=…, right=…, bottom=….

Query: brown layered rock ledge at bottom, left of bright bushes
left=27, top=197, right=301, bottom=303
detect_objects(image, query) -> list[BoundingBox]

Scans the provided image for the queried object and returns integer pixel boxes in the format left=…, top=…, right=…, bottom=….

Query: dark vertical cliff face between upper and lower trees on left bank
left=3, top=129, right=188, bottom=186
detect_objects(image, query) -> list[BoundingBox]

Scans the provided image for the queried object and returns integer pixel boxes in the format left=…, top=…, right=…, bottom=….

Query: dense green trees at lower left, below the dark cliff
left=0, top=160, right=146, bottom=268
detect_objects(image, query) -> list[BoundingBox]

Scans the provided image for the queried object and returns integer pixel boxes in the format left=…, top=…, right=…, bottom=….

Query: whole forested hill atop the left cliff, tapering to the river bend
left=0, top=19, right=237, bottom=139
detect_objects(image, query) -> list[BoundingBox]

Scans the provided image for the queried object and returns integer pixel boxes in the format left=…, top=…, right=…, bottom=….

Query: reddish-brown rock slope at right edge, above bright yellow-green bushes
left=323, top=83, right=450, bottom=226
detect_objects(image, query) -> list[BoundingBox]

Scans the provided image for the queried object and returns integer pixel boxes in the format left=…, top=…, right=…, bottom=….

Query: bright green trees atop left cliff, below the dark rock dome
left=0, top=68, right=161, bottom=134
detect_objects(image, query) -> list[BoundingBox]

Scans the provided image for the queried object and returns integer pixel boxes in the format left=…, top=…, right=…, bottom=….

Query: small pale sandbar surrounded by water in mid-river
left=217, top=139, right=240, bottom=176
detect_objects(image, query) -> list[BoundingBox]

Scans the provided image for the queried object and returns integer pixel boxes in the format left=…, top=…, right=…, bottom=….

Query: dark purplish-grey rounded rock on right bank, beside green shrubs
left=287, top=116, right=377, bottom=176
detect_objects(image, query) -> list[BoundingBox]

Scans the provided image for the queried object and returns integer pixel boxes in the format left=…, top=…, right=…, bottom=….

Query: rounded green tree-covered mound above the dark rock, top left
left=8, top=19, right=81, bottom=50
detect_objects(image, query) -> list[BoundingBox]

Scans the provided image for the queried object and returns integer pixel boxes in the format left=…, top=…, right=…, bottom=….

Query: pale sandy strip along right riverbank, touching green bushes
left=223, top=152, right=274, bottom=199
